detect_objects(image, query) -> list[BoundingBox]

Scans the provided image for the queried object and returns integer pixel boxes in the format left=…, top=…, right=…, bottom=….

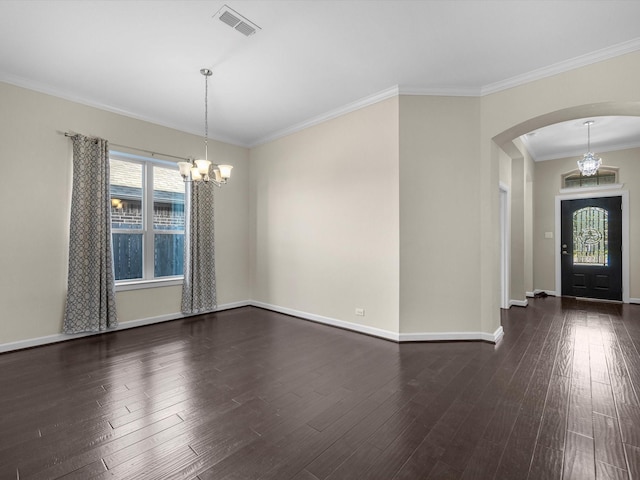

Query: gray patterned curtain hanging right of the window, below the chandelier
left=182, top=183, right=217, bottom=314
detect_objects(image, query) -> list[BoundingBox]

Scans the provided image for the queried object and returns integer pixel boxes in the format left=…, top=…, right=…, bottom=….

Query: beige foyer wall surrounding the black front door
left=533, top=148, right=640, bottom=299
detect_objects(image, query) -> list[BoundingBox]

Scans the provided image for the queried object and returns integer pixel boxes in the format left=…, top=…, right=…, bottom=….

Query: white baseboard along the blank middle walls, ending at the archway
left=251, top=300, right=504, bottom=343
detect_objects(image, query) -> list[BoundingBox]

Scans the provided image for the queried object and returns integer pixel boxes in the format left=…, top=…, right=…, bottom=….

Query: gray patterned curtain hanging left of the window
left=63, top=135, right=118, bottom=333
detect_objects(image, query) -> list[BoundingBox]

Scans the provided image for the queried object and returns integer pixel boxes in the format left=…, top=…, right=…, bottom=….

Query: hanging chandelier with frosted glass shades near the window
left=178, top=68, right=233, bottom=187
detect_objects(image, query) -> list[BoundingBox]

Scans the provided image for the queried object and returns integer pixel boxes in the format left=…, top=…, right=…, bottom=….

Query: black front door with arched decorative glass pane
left=561, top=197, right=622, bottom=300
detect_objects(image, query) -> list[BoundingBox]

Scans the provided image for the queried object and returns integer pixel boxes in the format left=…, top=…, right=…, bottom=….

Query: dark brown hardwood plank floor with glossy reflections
left=0, top=297, right=640, bottom=480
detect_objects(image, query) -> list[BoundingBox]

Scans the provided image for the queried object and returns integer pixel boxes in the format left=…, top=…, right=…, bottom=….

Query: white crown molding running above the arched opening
left=480, top=38, right=640, bottom=96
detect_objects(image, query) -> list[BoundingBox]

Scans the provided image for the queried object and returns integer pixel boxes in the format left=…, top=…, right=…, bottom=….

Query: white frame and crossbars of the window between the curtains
left=109, top=150, right=187, bottom=292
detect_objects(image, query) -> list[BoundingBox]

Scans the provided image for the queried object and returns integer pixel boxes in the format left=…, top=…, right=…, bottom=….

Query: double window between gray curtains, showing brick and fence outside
left=110, top=152, right=185, bottom=282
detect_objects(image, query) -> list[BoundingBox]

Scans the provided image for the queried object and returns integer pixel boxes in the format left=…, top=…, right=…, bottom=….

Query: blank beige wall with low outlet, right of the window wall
left=250, top=97, right=399, bottom=332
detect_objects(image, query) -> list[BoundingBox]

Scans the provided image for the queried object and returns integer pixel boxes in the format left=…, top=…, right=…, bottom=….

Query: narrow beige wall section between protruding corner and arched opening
left=400, top=96, right=482, bottom=333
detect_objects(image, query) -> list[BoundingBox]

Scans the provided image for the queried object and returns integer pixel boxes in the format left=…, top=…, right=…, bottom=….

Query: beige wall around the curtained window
left=0, top=83, right=250, bottom=345
